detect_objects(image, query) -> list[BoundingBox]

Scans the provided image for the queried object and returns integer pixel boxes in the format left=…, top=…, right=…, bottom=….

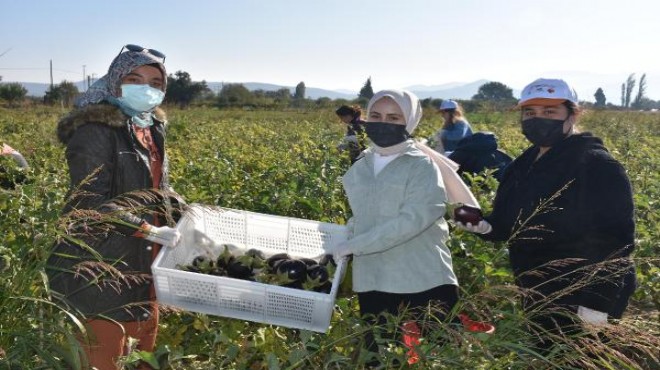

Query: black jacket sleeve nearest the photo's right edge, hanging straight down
left=580, top=154, right=635, bottom=312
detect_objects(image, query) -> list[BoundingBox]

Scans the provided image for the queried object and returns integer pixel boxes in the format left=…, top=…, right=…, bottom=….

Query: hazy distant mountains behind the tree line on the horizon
left=14, top=80, right=500, bottom=100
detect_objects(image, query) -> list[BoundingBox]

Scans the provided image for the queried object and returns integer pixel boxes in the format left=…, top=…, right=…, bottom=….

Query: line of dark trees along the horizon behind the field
left=0, top=71, right=660, bottom=110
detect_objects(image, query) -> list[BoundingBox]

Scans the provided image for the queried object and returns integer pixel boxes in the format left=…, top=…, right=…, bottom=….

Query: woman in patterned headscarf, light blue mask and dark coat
left=49, top=45, right=179, bottom=370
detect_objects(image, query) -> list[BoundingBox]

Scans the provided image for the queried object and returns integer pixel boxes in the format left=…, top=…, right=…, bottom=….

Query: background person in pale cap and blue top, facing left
left=433, top=100, right=472, bottom=155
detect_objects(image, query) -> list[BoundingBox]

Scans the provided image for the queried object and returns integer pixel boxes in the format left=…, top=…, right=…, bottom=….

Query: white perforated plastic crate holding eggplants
left=151, top=205, right=347, bottom=332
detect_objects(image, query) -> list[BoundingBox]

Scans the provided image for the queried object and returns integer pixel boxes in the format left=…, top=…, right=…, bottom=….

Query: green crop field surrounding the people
left=0, top=107, right=660, bottom=370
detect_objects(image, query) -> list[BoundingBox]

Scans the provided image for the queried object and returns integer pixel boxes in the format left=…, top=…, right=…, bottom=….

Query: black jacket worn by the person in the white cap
left=484, top=133, right=635, bottom=317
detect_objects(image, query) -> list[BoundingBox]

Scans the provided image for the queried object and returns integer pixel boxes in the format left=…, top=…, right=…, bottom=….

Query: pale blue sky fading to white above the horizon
left=0, top=0, right=660, bottom=103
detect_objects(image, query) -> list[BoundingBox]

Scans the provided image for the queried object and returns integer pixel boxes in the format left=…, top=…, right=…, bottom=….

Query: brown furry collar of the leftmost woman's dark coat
left=57, top=104, right=167, bottom=144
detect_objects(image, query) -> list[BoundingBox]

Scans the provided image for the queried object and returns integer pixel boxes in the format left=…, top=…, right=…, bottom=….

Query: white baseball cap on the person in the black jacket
left=517, top=78, right=578, bottom=107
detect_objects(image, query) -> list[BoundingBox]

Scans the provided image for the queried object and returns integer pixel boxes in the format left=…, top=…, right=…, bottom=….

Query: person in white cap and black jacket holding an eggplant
left=456, top=78, right=636, bottom=349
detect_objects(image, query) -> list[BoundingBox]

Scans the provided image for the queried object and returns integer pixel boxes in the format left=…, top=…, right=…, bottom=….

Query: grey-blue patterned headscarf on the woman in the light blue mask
left=75, top=51, right=167, bottom=108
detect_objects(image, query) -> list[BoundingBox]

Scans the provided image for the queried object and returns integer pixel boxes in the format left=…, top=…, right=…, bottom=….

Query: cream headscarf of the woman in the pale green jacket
left=367, top=90, right=481, bottom=208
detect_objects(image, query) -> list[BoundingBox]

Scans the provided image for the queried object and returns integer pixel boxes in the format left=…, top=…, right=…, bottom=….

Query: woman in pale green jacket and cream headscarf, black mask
left=328, top=90, right=458, bottom=364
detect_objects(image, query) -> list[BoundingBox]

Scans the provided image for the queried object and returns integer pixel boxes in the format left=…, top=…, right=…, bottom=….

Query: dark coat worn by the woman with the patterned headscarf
left=48, top=104, right=179, bottom=321
